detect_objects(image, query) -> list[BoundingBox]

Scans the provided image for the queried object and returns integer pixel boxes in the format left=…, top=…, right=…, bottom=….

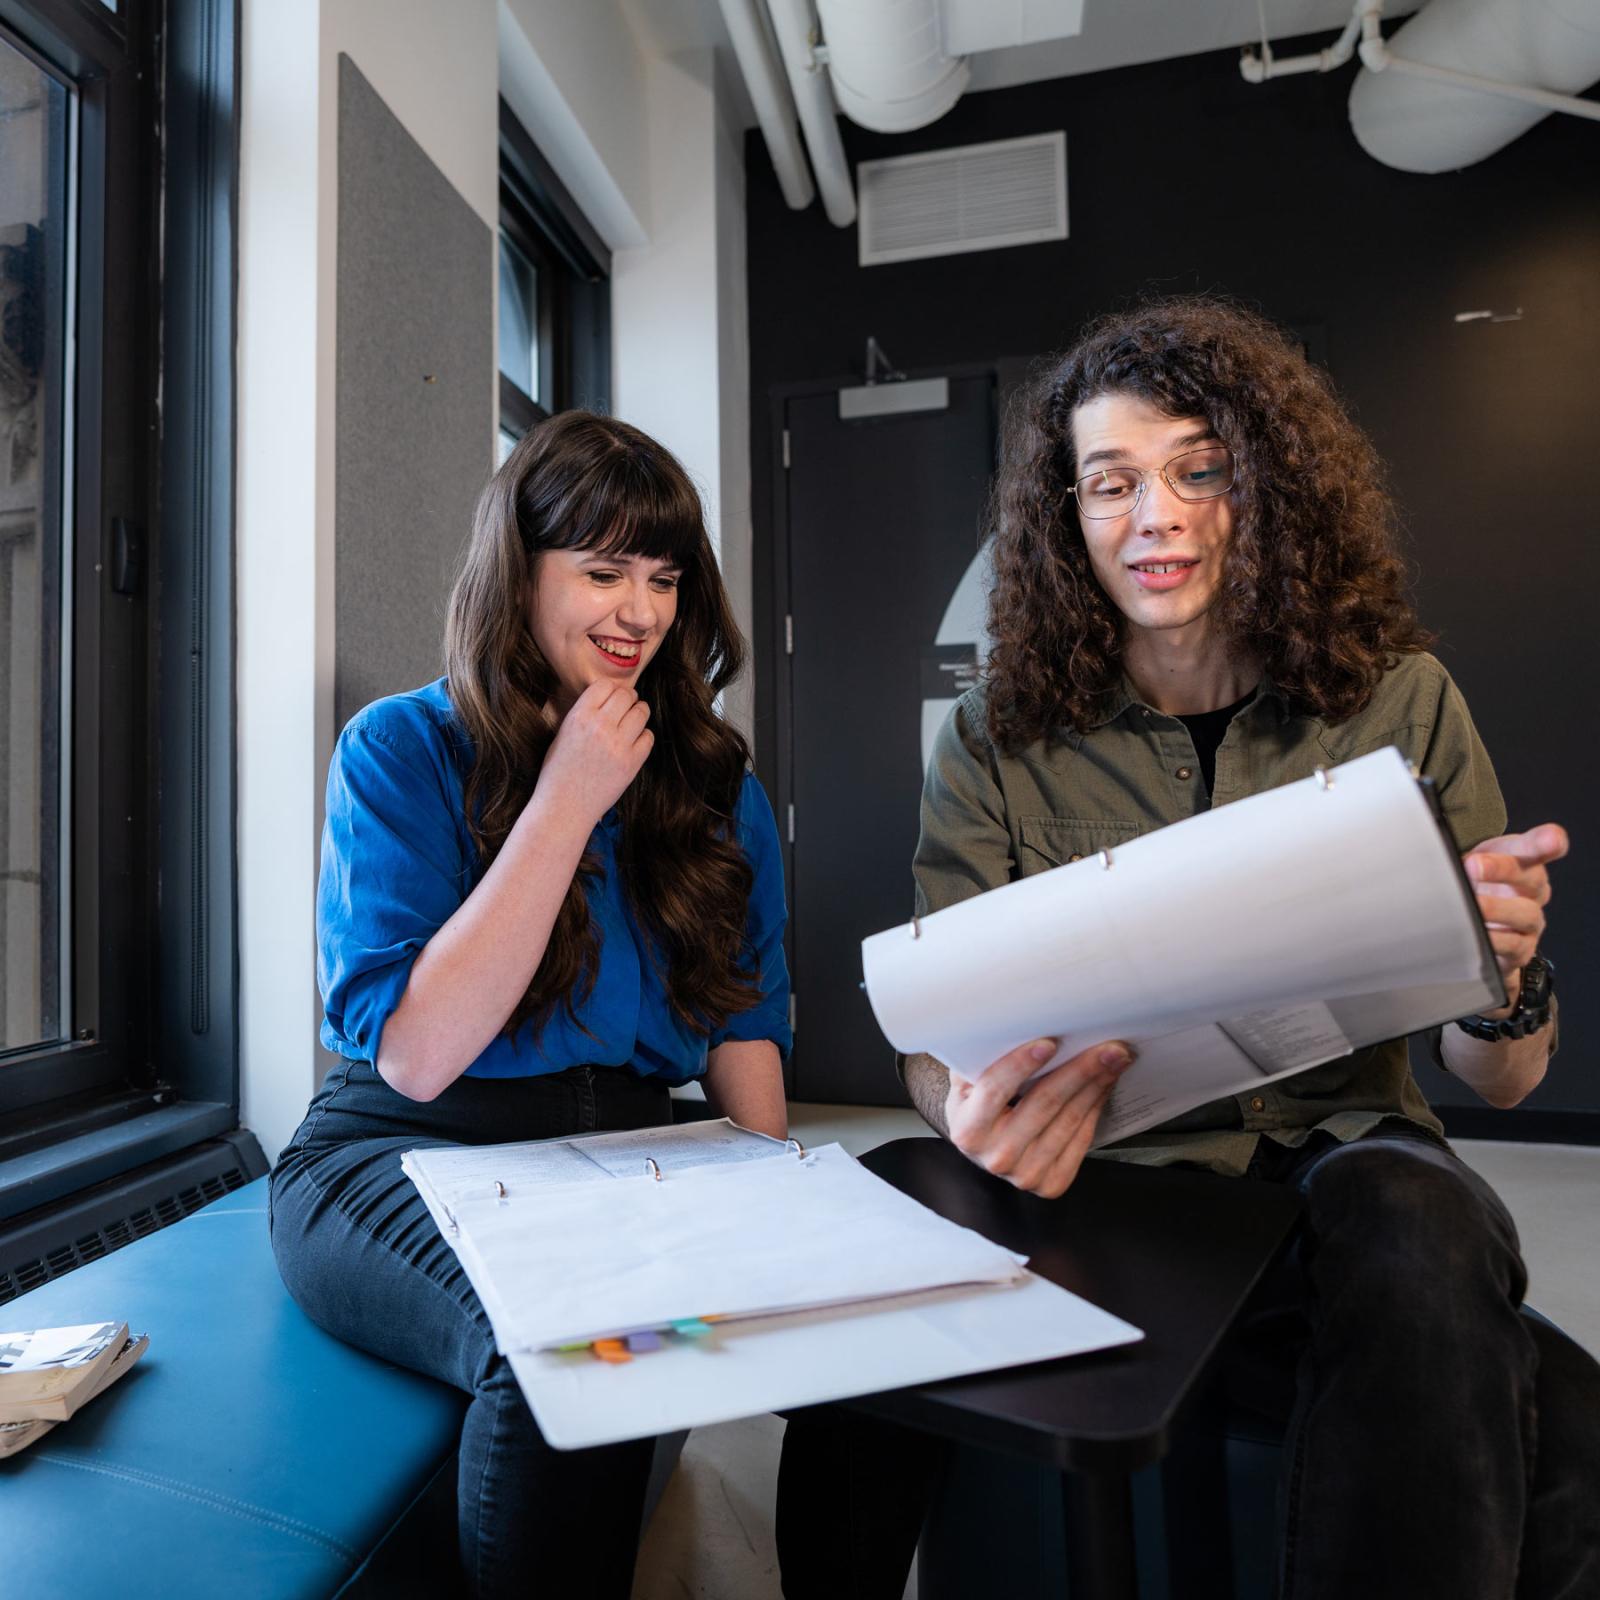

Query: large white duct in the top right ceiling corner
left=1350, top=0, right=1600, bottom=173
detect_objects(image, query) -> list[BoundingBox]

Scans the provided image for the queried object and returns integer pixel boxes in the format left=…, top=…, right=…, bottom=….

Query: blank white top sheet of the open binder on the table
left=454, top=1144, right=1019, bottom=1349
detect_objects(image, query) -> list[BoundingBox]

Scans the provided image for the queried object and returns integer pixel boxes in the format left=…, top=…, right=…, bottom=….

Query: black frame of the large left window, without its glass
left=0, top=0, right=238, bottom=1219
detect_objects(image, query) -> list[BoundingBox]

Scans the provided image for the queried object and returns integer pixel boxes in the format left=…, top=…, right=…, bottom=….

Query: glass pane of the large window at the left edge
left=0, top=38, right=70, bottom=1050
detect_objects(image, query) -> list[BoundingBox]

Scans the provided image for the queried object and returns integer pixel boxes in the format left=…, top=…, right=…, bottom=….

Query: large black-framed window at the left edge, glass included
left=0, top=0, right=237, bottom=1203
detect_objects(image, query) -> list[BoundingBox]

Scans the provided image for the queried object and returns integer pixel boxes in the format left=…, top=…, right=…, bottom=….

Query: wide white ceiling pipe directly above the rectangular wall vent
left=816, top=0, right=971, bottom=133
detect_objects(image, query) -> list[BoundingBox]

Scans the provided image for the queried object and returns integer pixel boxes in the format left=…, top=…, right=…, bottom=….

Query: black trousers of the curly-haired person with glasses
left=778, top=1123, right=1600, bottom=1600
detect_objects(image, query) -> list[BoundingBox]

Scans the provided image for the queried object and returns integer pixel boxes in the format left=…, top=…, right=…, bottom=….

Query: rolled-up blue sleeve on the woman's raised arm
left=317, top=718, right=470, bottom=1061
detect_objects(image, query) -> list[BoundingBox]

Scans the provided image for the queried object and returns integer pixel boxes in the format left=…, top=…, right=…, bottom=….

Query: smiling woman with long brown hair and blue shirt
left=272, top=411, right=789, bottom=1600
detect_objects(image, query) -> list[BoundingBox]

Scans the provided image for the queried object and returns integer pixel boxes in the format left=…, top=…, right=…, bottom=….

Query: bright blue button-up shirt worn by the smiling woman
left=317, top=678, right=790, bottom=1083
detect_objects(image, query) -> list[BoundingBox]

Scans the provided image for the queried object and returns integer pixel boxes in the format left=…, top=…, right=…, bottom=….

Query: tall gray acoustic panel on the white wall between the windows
left=334, top=56, right=494, bottom=728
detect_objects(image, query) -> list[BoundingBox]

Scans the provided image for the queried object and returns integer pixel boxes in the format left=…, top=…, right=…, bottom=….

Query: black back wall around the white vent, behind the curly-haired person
left=746, top=38, right=1600, bottom=1136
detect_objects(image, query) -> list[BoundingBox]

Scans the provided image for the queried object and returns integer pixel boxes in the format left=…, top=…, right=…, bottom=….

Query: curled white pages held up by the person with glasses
left=862, top=749, right=1498, bottom=1100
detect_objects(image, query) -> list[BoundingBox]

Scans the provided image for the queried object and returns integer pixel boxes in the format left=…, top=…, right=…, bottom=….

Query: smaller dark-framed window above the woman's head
left=499, top=101, right=611, bottom=461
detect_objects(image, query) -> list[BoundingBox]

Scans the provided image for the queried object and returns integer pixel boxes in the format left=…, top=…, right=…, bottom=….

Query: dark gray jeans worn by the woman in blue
left=270, top=1062, right=670, bottom=1600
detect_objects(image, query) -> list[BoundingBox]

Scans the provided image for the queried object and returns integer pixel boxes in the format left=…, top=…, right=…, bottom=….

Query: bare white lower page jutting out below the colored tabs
left=510, top=1272, right=1144, bottom=1450
